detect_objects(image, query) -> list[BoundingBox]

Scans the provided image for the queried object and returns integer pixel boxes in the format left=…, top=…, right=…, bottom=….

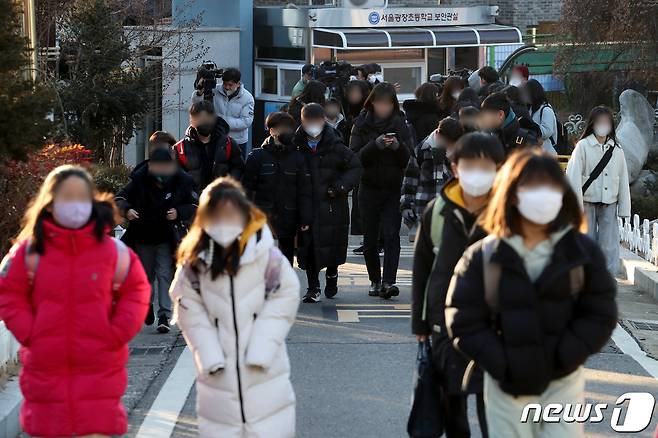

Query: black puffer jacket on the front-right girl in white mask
left=446, top=230, right=617, bottom=395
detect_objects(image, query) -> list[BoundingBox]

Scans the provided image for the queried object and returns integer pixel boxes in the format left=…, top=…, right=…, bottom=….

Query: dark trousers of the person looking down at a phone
left=359, top=185, right=402, bottom=284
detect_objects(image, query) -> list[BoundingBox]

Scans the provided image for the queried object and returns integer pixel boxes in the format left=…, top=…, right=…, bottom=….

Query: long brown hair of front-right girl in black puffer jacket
left=480, top=149, right=587, bottom=237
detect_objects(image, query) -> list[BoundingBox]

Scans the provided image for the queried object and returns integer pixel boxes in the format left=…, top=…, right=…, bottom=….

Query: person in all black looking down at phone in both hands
left=350, top=82, right=413, bottom=299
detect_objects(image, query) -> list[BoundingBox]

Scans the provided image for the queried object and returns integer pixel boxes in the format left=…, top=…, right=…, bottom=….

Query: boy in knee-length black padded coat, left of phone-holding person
left=294, top=103, right=361, bottom=303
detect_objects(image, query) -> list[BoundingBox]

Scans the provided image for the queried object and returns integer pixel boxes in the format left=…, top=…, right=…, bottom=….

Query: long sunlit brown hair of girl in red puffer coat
left=14, top=165, right=119, bottom=254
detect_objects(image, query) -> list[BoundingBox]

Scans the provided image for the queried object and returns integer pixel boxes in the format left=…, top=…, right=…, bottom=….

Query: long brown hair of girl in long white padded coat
left=177, top=176, right=255, bottom=279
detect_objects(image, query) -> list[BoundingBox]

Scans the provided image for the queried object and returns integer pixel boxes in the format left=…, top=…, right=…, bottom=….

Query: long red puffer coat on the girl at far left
left=0, top=221, right=150, bottom=437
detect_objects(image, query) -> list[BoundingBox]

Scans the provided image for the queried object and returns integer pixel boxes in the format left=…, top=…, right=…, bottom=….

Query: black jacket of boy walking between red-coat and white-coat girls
left=115, top=165, right=199, bottom=249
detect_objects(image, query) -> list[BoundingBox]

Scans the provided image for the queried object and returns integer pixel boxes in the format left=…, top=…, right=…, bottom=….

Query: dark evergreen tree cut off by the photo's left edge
left=0, top=0, right=51, bottom=163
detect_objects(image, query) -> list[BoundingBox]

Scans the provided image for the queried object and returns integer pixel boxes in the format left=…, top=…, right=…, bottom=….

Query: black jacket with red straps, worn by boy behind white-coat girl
left=174, top=117, right=244, bottom=193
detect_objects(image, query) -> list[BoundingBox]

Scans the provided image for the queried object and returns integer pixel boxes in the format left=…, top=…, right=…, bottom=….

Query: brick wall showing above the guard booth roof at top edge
left=254, top=0, right=562, bottom=33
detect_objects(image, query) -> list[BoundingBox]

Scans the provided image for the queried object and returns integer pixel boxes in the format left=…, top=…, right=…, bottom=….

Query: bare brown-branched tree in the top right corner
left=555, top=0, right=658, bottom=111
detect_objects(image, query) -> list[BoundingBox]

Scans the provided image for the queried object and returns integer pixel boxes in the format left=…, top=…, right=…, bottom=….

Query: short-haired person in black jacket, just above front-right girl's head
left=478, top=92, right=538, bottom=155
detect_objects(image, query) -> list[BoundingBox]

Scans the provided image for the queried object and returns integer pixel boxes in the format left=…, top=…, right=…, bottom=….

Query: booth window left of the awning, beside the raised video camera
left=255, top=62, right=302, bottom=101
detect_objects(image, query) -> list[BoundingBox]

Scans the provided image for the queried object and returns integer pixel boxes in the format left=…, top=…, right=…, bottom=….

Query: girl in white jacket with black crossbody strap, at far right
left=567, top=106, right=631, bottom=275
